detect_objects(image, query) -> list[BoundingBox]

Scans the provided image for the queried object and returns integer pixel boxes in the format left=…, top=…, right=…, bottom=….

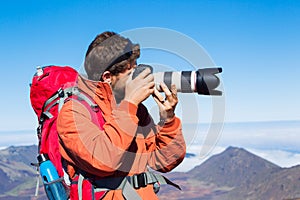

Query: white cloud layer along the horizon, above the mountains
left=0, top=121, right=300, bottom=171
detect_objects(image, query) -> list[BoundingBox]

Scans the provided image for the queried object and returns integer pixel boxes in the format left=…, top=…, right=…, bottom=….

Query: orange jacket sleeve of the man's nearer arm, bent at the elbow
left=57, top=100, right=138, bottom=177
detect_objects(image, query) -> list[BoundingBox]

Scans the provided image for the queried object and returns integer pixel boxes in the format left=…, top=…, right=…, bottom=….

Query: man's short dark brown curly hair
left=84, top=31, right=140, bottom=81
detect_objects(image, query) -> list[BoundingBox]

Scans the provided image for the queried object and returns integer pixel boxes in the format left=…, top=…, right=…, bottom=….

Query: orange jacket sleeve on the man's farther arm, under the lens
left=137, top=104, right=186, bottom=172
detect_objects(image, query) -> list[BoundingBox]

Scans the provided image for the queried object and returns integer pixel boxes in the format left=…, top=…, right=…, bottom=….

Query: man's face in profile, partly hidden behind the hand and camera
left=111, top=65, right=136, bottom=101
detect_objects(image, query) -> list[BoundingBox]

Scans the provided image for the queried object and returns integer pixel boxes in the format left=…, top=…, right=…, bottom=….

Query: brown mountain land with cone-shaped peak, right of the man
left=160, top=147, right=300, bottom=200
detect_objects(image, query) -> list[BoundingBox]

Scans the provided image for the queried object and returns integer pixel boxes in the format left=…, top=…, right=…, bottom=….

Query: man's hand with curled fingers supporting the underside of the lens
left=153, top=83, right=178, bottom=123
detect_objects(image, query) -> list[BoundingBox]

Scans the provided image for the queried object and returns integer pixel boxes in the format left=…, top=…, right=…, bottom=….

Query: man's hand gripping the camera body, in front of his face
left=124, top=68, right=155, bottom=106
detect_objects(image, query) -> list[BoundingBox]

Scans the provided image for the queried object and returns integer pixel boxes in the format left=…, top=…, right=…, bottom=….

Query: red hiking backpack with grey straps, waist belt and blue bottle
left=30, top=66, right=180, bottom=200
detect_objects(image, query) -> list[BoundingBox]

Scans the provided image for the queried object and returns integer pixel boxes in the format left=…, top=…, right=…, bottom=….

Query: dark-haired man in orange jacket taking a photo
left=57, top=32, right=186, bottom=200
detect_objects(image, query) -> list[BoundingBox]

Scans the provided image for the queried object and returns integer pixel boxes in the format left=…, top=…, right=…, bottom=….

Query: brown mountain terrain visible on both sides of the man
left=0, top=146, right=300, bottom=200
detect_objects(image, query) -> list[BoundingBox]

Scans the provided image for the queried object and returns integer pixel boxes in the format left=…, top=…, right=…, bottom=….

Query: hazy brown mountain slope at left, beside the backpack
left=0, top=145, right=43, bottom=200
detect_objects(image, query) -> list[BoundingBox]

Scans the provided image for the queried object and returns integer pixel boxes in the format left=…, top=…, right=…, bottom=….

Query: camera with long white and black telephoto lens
left=132, top=64, right=222, bottom=96
